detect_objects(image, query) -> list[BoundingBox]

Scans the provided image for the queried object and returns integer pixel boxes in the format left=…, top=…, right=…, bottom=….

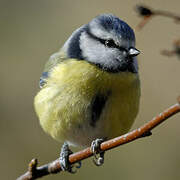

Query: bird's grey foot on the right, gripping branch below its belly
left=91, top=139, right=105, bottom=166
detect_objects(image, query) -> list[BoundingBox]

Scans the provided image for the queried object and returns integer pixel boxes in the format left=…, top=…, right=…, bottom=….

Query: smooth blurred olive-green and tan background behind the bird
left=0, top=0, right=180, bottom=180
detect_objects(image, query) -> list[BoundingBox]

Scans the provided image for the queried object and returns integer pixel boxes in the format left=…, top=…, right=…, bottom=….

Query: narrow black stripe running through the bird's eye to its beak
left=87, top=31, right=127, bottom=52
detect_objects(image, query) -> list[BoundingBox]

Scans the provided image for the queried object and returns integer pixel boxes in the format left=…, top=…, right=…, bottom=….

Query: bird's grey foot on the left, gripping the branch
left=59, top=142, right=81, bottom=174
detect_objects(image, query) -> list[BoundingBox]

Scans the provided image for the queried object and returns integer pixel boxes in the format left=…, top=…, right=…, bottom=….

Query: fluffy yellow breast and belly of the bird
left=35, top=59, right=140, bottom=146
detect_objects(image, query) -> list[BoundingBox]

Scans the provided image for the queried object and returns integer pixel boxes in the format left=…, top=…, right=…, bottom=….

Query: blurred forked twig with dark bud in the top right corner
left=136, top=5, right=180, bottom=30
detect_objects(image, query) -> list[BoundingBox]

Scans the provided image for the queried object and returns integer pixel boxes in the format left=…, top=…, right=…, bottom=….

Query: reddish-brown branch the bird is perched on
left=17, top=98, right=180, bottom=180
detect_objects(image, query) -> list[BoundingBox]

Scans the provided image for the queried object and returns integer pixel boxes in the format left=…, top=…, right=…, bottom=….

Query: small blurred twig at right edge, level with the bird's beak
left=161, top=39, right=180, bottom=59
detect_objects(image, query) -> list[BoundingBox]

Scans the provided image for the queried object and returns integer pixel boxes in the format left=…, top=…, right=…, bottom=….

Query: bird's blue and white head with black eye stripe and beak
left=63, top=14, right=140, bottom=73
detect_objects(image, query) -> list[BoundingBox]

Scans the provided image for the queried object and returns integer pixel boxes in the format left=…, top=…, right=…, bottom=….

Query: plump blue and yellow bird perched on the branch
left=34, top=14, right=141, bottom=172
